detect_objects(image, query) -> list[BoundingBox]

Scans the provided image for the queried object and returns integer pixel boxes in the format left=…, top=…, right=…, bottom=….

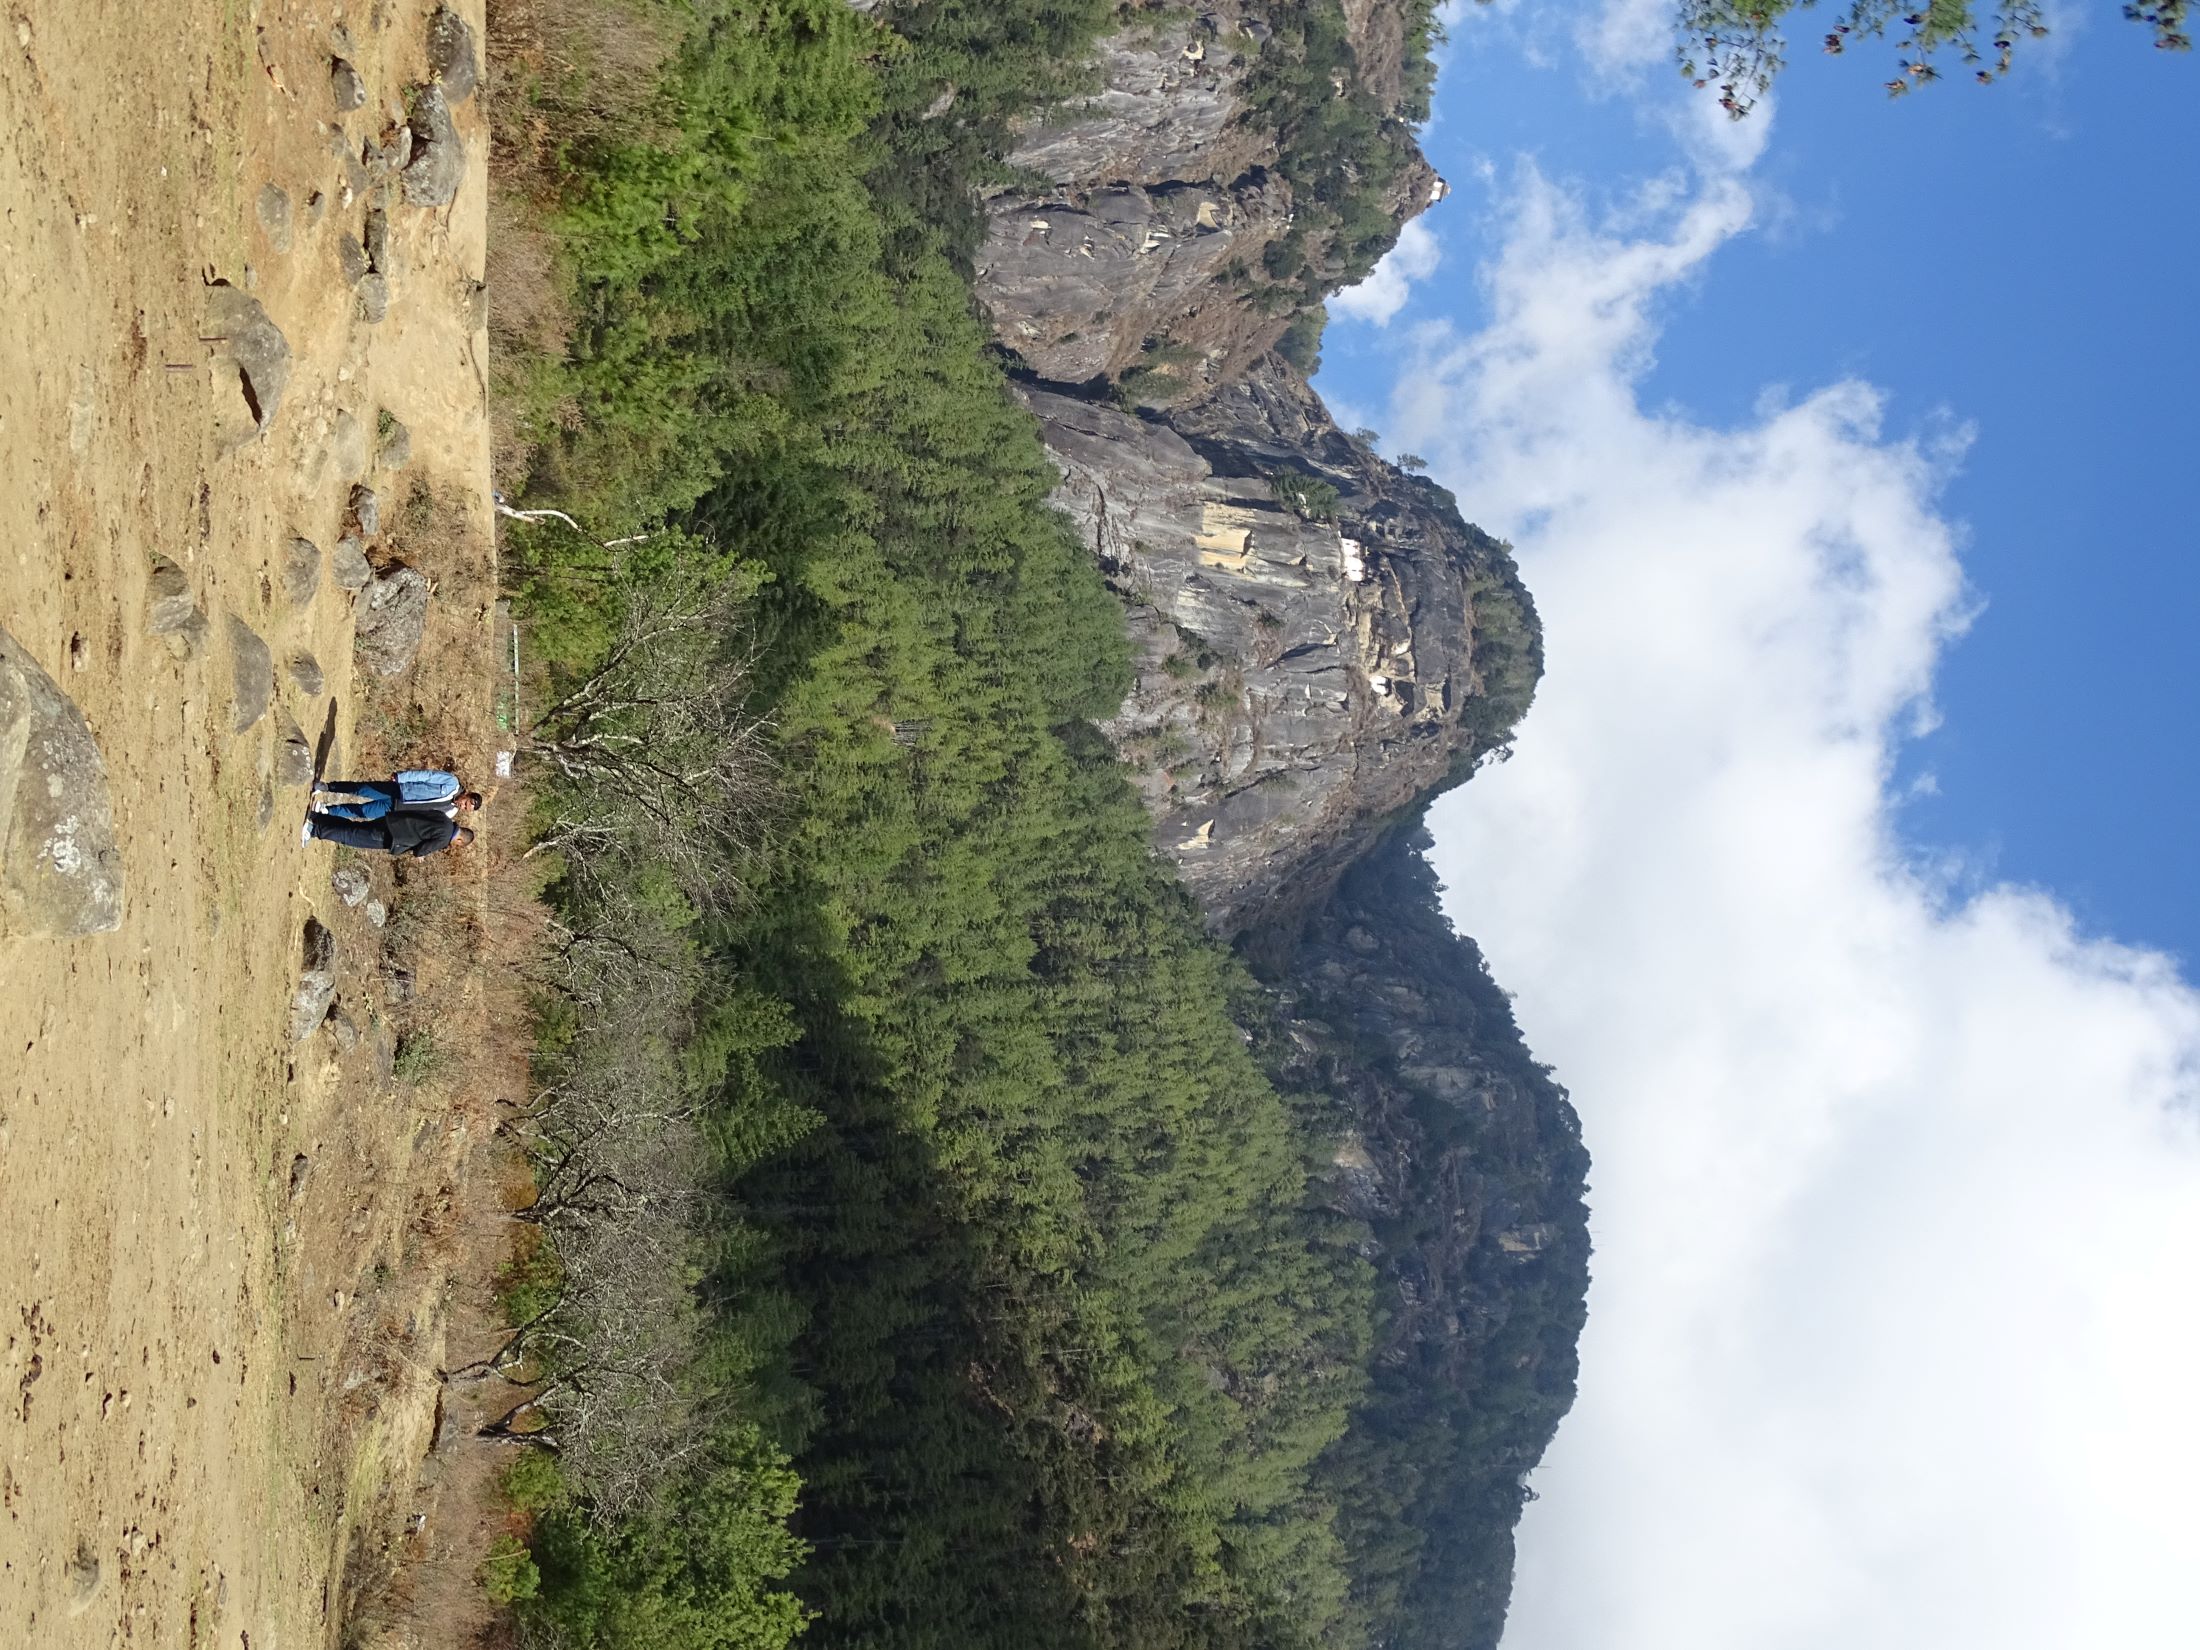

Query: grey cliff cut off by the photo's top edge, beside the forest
left=977, top=0, right=1443, bottom=394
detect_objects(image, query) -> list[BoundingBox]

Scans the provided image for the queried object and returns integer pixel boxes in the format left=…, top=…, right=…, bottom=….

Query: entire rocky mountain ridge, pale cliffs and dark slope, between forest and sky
left=977, top=0, right=1588, bottom=1650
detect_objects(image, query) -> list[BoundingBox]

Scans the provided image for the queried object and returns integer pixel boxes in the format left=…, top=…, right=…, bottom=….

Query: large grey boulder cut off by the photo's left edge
left=0, top=629, right=123, bottom=939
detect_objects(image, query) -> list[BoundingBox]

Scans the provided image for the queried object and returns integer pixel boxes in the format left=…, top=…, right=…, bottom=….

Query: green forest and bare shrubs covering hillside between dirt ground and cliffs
left=477, top=0, right=1584, bottom=1650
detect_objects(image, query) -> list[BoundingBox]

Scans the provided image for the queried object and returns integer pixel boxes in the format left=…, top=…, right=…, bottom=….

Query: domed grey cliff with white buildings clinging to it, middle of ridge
left=1027, top=374, right=1536, bottom=935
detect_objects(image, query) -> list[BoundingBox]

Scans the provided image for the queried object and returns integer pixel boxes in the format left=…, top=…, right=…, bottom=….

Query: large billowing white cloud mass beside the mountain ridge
left=1388, top=161, right=2200, bottom=1650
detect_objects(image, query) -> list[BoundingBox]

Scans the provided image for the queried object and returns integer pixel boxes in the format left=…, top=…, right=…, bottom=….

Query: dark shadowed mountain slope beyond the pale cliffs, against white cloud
left=1276, top=827, right=1588, bottom=1650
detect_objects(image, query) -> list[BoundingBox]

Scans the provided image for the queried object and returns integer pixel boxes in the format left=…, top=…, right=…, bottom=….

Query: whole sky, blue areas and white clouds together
left=1320, top=0, right=2200, bottom=1650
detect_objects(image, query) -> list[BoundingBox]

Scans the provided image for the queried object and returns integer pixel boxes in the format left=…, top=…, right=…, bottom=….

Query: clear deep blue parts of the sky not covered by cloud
left=1322, top=4, right=2200, bottom=959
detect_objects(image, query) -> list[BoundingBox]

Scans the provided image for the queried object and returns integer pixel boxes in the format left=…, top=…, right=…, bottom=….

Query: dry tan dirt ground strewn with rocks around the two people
left=0, top=0, right=495, bottom=1650
